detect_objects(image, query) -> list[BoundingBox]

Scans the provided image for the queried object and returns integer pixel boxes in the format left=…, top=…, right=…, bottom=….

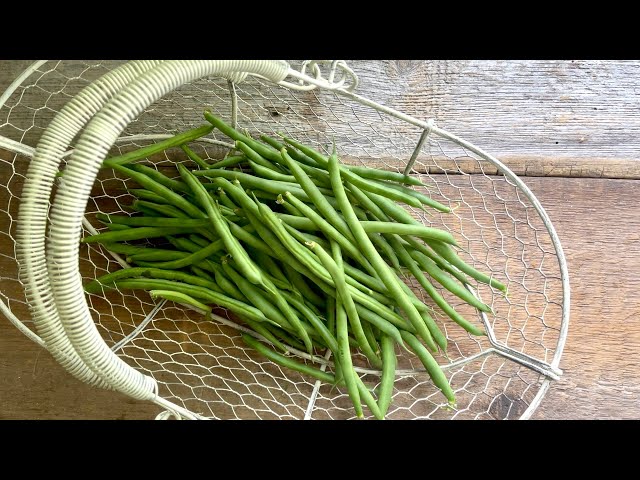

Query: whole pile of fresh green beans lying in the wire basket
left=82, top=111, right=506, bottom=419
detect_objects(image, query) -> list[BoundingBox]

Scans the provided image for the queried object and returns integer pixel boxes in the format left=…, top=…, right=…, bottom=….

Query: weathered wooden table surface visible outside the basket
left=0, top=60, right=640, bottom=419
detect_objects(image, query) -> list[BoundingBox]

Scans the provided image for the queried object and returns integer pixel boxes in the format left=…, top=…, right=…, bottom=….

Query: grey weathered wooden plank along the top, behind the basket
left=0, top=60, right=640, bottom=178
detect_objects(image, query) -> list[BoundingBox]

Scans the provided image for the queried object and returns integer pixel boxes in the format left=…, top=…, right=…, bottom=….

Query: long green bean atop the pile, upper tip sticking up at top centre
left=328, top=154, right=433, bottom=350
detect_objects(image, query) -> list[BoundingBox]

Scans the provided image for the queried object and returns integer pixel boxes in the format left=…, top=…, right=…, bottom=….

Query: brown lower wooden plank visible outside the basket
left=0, top=178, right=640, bottom=419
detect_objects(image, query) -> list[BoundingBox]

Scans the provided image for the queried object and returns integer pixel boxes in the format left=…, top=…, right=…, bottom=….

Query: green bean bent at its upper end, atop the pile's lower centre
left=307, top=242, right=382, bottom=367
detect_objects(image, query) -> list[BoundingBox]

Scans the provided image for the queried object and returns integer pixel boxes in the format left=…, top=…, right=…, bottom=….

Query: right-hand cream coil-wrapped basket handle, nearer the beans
left=39, top=60, right=289, bottom=400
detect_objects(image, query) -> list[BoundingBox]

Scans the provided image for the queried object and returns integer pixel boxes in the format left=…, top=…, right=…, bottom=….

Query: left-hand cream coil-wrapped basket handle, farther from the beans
left=16, top=62, right=164, bottom=388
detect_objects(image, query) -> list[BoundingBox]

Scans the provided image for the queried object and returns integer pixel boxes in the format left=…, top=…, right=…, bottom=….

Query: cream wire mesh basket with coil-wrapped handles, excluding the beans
left=0, top=61, right=569, bottom=419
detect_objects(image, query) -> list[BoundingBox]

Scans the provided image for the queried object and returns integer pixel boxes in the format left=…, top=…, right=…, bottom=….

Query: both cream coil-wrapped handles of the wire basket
left=18, top=60, right=289, bottom=400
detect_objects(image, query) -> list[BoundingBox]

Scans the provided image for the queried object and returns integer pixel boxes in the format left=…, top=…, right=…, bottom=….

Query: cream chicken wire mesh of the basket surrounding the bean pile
left=0, top=61, right=566, bottom=419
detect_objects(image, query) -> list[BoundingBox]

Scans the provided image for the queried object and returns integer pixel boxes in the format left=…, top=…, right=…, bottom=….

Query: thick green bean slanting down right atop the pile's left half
left=178, top=165, right=262, bottom=284
